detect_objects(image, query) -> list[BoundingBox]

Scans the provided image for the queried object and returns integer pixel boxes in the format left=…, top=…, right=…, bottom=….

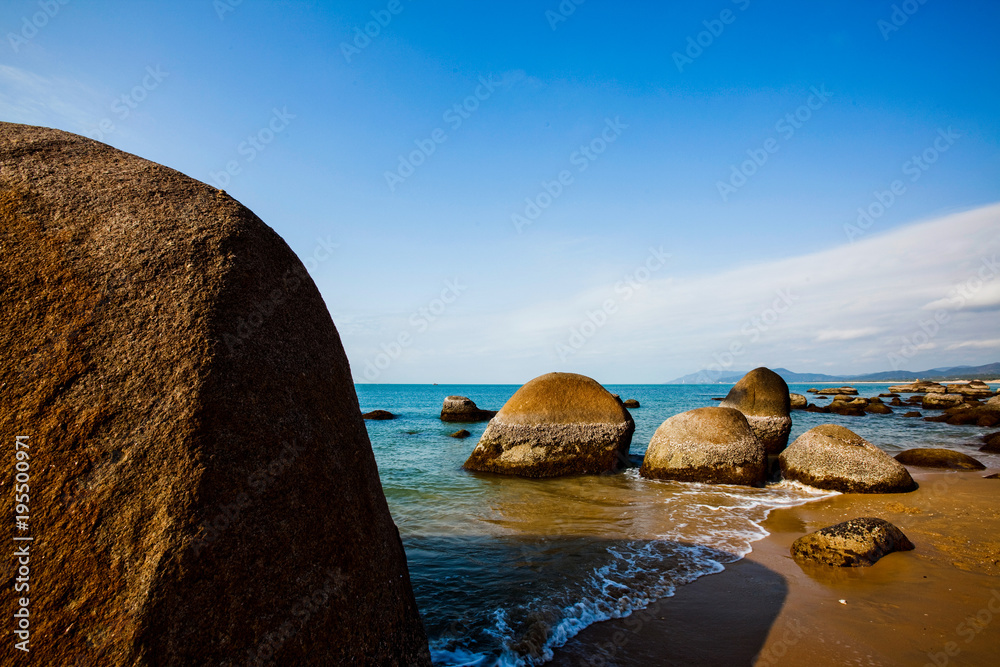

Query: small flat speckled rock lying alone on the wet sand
left=791, top=517, right=915, bottom=567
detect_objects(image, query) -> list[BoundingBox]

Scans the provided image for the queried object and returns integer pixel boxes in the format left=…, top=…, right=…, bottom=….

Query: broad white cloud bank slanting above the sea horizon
left=349, top=204, right=1000, bottom=382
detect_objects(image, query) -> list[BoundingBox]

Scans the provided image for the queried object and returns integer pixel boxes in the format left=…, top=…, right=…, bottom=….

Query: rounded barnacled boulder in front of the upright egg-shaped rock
left=639, top=408, right=767, bottom=486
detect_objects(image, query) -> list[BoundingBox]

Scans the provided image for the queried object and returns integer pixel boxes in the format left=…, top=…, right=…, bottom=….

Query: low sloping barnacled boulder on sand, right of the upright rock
left=778, top=424, right=917, bottom=493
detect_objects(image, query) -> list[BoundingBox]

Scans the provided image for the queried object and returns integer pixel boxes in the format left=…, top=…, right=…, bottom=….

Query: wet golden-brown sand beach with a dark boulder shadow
left=551, top=468, right=1000, bottom=667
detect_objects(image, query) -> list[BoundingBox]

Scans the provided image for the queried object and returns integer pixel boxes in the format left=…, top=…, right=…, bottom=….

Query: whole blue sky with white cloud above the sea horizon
left=0, top=0, right=1000, bottom=383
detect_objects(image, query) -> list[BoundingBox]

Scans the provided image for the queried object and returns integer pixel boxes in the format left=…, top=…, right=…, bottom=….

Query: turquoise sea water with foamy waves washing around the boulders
left=357, top=384, right=1000, bottom=667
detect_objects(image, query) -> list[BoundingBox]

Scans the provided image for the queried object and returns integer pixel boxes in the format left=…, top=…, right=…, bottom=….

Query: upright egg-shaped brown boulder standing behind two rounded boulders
left=719, top=367, right=792, bottom=454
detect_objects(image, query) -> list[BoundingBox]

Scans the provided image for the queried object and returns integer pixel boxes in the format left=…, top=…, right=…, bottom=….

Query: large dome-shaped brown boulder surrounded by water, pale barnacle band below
left=465, top=373, right=635, bottom=477
